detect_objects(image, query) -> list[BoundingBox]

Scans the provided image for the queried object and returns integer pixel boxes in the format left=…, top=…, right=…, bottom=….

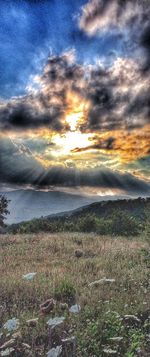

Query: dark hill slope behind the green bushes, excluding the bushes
left=8, top=197, right=150, bottom=233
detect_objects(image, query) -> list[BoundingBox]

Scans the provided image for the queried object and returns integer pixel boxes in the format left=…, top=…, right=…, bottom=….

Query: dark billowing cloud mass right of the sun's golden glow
left=81, top=58, right=150, bottom=131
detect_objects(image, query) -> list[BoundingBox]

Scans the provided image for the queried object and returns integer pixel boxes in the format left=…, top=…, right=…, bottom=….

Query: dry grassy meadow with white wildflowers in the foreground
left=0, top=233, right=150, bottom=357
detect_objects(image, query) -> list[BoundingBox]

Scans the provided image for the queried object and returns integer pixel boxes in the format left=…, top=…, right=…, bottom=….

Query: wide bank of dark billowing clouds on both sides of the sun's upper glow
left=0, top=46, right=150, bottom=132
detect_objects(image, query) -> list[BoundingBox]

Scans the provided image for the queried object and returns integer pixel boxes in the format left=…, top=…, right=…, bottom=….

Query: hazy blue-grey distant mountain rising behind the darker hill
left=1, top=189, right=119, bottom=224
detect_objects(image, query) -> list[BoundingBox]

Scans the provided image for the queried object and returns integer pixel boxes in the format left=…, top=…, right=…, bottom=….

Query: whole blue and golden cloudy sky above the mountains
left=0, top=0, right=150, bottom=195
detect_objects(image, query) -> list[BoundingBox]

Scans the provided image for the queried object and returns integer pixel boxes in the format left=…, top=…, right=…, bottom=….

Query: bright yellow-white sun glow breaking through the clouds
left=34, top=92, right=94, bottom=164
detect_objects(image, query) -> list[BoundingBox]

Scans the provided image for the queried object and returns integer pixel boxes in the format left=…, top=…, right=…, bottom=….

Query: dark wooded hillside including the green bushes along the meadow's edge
left=7, top=198, right=150, bottom=235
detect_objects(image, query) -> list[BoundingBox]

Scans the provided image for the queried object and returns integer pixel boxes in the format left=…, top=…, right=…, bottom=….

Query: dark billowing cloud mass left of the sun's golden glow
left=0, top=52, right=83, bottom=131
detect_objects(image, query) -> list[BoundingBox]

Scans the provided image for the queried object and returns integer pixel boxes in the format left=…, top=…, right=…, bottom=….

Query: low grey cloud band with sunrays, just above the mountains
left=0, top=139, right=150, bottom=194
